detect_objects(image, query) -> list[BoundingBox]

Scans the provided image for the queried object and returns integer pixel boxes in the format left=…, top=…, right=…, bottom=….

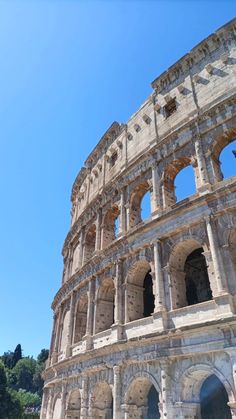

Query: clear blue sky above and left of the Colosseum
left=0, top=0, right=235, bottom=355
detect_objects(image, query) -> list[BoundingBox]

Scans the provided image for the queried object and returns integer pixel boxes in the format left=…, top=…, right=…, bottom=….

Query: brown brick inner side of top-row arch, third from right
left=129, top=181, right=150, bottom=228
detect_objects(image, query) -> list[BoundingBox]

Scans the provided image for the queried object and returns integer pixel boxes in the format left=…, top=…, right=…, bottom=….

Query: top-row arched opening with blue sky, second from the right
left=162, top=157, right=196, bottom=208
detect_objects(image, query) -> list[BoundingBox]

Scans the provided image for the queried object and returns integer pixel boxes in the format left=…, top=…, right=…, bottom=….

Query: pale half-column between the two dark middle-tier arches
left=153, top=240, right=165, bottom=312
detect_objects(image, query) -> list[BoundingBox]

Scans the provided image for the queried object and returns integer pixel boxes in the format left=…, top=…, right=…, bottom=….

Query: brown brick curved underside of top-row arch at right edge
left=211, top=128, right=236, bottom=182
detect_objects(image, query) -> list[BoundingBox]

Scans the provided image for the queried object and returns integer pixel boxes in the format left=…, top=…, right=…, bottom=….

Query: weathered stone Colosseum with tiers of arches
left=41, top=19, right=236, bottom=419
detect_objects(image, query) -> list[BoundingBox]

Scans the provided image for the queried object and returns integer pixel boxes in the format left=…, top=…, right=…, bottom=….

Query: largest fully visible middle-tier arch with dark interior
left=169, top=238, right=212, bottom=309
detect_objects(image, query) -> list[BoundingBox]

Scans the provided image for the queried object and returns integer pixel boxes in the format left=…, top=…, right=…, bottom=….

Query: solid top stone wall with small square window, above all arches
left=68, top=19, right=236, bottom=233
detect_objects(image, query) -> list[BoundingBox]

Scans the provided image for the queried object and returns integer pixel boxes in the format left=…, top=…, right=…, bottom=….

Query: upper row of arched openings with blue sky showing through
left=75, top=136, right=236, bottom=265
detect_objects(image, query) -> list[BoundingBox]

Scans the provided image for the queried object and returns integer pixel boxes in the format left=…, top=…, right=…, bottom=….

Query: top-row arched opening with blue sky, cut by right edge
left=211, top=128, right=236, bottom=182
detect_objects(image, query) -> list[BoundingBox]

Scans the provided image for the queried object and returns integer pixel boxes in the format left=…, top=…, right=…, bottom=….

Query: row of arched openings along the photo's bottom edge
left=52, top=374, right=232, bottom=419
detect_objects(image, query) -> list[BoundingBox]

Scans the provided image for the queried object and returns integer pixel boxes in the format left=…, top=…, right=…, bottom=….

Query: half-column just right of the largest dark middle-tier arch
left=205, top=216, right=227, bottom=294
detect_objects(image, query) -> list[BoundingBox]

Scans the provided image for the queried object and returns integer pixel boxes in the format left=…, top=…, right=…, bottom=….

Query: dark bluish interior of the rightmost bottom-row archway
left=200, top=374, right=232, bottom=419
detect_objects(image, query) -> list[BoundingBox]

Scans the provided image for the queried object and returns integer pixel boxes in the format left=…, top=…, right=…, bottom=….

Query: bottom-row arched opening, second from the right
left=126, top=377, right=161, bottom=419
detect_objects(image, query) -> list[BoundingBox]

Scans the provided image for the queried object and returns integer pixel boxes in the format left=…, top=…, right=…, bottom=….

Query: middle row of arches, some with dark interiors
left=55, top=229, right=236, bottom=352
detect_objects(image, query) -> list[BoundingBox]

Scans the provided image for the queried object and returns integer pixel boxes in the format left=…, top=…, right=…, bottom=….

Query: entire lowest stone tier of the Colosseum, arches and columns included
left=41, top=347, right=236, bottom=419
